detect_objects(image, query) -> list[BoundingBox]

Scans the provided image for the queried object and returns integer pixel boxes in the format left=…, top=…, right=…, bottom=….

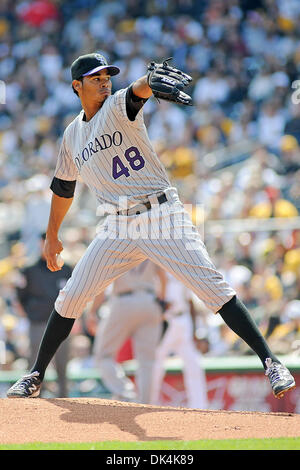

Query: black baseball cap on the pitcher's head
left=71, top=52, right=120, bottom=80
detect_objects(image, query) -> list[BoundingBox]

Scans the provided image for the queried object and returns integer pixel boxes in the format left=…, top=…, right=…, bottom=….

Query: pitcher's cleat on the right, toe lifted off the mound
left=265, top=357, right=296, bottom=398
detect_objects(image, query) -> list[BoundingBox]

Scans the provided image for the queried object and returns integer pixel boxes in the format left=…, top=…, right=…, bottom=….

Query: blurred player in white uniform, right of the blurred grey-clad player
left=151, top=274, right=208, bottom=409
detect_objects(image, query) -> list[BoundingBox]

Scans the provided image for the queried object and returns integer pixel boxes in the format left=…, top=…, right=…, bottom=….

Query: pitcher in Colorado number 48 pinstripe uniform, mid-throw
left=7, top=53, right=295, bottom=397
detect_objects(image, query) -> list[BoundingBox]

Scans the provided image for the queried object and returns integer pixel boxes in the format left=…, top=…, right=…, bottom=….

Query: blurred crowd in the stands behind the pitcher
left=0, top=0, right=300, bottom=404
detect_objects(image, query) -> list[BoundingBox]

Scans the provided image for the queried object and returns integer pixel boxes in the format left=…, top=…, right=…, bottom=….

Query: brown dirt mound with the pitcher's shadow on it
left=0, top=398, right=300, bottom=444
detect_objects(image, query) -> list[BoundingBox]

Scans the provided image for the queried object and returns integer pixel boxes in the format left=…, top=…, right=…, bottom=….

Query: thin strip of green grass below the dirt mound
left=0, top=437, right=300, bottom=450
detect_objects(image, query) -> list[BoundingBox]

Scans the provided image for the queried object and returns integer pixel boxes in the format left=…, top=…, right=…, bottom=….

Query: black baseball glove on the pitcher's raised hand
left=147, top=57, right=192, bottom=106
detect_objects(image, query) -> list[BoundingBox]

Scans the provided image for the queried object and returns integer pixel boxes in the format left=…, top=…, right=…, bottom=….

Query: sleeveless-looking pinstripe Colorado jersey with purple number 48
left=54, top=89, right=170, bottom=206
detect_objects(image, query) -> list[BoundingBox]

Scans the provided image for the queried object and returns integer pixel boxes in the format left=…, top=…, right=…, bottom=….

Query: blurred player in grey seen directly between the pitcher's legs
left=88, top=260, right=166, bottom=403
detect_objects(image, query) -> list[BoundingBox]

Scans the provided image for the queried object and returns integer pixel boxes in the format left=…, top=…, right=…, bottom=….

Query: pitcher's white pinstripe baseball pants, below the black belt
left=55, top=189, right=235, bottom=318
